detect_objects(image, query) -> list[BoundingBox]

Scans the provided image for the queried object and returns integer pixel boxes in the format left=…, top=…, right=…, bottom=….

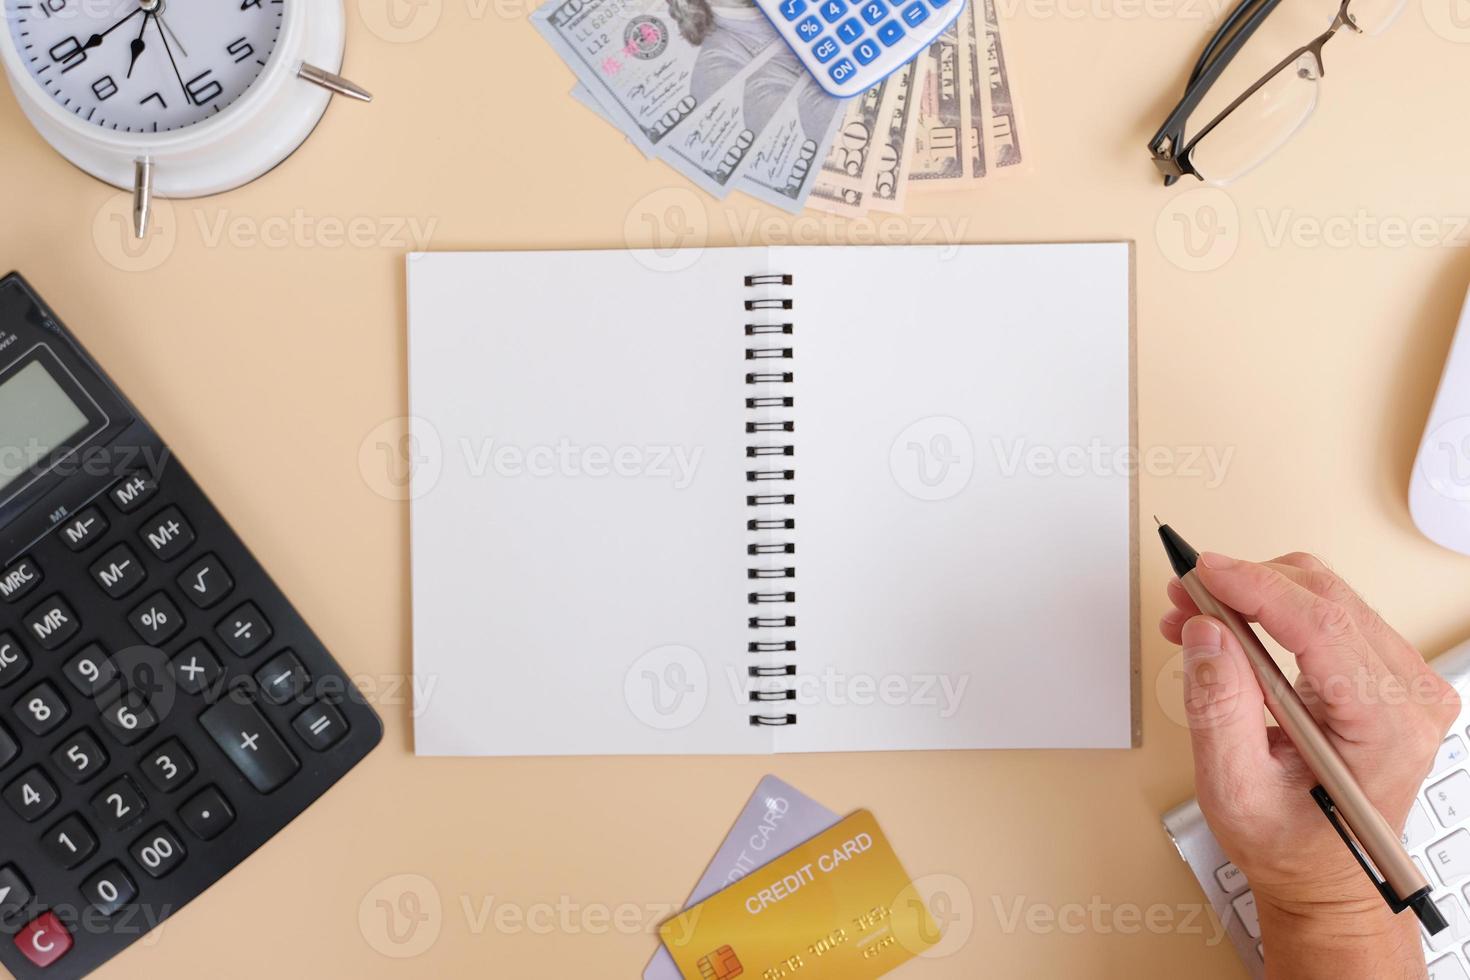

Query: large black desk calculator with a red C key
left=0, top=275, right=382, bottom=980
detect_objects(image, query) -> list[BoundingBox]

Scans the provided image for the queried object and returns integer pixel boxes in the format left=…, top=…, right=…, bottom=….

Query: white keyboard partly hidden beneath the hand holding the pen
left=1164, top=642, right=1470, bottom=980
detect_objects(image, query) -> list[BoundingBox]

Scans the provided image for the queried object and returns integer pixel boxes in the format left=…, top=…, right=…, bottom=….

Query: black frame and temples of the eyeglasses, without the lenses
left=1148, top=0, right=1363, bottom=187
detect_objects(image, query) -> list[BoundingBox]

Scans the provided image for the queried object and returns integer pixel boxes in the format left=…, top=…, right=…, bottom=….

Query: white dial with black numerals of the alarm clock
left=0, top=0, right=283, bottom=132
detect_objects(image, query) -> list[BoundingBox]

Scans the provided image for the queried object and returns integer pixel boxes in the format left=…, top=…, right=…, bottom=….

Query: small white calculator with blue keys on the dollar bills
left=756, top=0, right=964, bottom=98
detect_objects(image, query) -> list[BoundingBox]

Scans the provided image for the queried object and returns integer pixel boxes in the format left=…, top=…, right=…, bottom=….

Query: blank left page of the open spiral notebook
left=409, top=248, right=773, bottom=755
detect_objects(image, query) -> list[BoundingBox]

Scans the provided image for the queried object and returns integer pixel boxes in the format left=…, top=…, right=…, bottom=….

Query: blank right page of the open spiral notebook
left=770, top=244, right=1135, bottom=752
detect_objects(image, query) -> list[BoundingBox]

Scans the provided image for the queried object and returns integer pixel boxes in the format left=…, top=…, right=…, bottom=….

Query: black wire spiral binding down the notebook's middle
left=745, top=275, right=797, bottom=727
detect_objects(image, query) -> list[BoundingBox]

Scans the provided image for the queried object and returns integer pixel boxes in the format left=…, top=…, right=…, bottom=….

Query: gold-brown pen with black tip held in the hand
left=1154, top=517, right=1449, bottom=936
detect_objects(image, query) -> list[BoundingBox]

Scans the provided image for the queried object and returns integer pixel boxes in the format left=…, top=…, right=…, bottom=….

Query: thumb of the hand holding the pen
left=1182, top=616, right=1270, bottom=796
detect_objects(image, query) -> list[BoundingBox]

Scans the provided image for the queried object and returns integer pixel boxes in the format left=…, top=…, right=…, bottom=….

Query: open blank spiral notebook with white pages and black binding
left=401, top=244, right=1138, bottom=755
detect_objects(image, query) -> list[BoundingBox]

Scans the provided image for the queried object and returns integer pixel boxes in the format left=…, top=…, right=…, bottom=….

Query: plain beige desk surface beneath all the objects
left=0, top=0, right=1470, bottom=980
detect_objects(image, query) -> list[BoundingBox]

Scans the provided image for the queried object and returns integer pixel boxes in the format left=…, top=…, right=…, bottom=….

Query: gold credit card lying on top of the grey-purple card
left=659, top=810, right=939, bottom=980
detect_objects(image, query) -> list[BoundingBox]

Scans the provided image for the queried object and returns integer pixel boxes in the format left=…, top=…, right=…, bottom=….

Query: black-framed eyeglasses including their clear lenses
left=1148, top=0, right=1407, bottom=185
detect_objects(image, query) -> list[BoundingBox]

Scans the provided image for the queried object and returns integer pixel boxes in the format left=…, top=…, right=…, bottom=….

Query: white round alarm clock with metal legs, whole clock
left=0, top=0, right=372, bottom=238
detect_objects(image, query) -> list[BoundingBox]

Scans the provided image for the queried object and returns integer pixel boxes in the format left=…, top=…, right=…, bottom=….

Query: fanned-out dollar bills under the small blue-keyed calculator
left=532, top=0, right=1023, bottom=215
